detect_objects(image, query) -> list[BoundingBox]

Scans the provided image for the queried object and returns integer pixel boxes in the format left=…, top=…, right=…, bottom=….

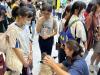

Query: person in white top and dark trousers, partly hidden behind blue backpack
left=58, top=5, right=71, bottom=63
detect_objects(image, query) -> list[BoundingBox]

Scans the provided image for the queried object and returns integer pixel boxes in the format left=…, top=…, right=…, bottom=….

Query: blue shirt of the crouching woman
left=62, top=58, right=89, bottom=75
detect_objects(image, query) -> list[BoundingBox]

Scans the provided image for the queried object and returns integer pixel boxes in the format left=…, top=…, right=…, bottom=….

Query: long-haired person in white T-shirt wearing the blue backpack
left=68, top=1, right=87, bottom=52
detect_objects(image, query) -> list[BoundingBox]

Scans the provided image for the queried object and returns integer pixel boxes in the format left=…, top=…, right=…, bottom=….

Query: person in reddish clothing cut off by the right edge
left=90, top=0, right=100, bottom=73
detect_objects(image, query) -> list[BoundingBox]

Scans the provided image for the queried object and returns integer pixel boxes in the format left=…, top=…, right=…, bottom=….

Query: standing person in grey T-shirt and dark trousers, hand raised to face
left=36, top=4, right=57, bottom=55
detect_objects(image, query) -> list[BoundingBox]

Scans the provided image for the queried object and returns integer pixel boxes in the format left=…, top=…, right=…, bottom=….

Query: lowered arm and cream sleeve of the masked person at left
left=7, top=30, right=28, bottom=67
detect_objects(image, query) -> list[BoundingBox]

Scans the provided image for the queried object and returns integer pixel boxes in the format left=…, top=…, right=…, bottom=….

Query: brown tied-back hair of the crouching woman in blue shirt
left=66, top=40, right=83, bottom=57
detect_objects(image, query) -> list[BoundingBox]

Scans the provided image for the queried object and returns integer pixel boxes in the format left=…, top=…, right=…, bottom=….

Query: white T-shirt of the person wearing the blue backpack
left=68, top=15, right=87, bottom=49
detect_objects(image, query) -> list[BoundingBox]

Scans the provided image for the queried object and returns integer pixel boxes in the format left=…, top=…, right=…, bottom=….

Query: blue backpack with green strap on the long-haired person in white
left=59, top=19, right=80, bottom=44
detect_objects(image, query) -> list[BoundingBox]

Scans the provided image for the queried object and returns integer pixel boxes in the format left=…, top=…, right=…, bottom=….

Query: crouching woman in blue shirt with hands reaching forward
left=43, top=40, right=89, bottom=75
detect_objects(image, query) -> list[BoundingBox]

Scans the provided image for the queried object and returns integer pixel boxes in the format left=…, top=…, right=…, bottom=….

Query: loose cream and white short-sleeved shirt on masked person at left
left=6, top=22, right=30, bottom=73
